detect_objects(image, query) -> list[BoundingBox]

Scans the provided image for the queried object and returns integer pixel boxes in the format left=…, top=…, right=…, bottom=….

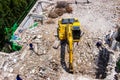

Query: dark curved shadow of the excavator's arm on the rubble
left=60, top=41, right=69, bottom=73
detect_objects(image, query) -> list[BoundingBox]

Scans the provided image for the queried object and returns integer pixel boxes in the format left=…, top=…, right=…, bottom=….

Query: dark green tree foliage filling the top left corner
left=0, top=0, right=32, bottom=50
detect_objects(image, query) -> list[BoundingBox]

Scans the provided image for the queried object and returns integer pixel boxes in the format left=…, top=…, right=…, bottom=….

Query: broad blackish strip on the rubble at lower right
left=96, top=48, right=113, bottom=79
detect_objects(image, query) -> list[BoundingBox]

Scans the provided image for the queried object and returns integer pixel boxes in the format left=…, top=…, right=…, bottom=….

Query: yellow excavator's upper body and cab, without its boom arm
left=58, top=18, right=81, bottom=42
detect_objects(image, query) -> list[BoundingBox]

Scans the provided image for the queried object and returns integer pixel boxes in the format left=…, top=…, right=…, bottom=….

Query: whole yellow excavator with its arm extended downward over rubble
left=57, top=18, right=82, bottom=73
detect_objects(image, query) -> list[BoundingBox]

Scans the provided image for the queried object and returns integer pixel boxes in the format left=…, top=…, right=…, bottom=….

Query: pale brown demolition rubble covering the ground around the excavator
left=0, top=0, right=120, bottom=80
